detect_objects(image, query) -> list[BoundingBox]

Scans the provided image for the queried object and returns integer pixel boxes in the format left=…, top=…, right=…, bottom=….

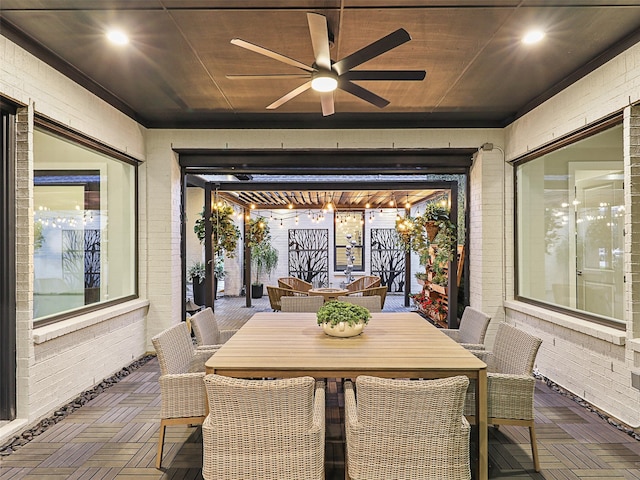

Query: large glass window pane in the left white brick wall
left=33, top=129, right=137, bottom=321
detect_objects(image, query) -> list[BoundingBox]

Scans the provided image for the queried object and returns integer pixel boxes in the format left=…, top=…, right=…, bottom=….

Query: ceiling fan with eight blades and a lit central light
left=227, top=13, right=426, bottom=116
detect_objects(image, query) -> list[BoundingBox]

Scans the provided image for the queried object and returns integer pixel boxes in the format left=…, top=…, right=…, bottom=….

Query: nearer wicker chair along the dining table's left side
left=151, top=322, right=217, bottom=468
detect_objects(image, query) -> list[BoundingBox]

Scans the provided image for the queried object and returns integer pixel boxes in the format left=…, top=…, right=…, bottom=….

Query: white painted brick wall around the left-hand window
left=0, top=36, right=145, bottom=443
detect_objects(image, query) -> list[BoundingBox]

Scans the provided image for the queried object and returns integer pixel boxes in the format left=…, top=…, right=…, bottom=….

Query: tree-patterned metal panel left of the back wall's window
left=289, top=228, right=329, bottom=287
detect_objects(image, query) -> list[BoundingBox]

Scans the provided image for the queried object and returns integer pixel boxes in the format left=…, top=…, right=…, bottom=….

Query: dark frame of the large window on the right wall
left=509, top=111, right=626, bottom=331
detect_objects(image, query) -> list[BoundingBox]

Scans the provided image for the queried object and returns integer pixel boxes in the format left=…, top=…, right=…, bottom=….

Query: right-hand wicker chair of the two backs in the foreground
left=344, top=376, right=471, bottom=480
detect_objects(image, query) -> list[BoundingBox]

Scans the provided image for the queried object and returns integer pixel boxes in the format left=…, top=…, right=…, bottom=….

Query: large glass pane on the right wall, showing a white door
left=516, top=125, right=625, bottom=324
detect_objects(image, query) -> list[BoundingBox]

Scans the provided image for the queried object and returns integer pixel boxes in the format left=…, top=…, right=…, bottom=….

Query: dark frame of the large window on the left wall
left=33, top=114, right=141, bottom=327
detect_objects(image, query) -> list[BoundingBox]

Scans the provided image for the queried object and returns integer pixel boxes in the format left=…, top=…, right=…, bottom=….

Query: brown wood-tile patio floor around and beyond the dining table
left=0, top=296, right=640, bottom=480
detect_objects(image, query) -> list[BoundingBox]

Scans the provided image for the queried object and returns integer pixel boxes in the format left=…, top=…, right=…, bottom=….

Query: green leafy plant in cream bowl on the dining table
left=317, top=300, right=371, bottom=337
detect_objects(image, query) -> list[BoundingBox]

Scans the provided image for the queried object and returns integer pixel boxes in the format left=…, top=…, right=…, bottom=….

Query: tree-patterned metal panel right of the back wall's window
left=371, top=228, right=406, bottom=292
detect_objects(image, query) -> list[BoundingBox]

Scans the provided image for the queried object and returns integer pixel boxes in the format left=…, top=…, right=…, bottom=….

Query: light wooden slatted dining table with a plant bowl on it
left=205, top=312, right=489, bottom=480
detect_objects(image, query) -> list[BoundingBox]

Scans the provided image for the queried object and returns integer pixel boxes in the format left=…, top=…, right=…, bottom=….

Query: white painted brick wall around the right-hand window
left=505, top=44, right=640, bottom=427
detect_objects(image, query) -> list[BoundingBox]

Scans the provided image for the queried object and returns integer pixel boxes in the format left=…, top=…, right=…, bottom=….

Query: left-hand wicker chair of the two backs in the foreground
left=202, top=375, right=325, bottom=480
